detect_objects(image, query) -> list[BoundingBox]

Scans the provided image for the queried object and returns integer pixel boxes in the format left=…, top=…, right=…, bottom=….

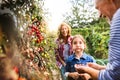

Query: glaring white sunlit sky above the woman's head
left=45, top=0, right=70, bottom=31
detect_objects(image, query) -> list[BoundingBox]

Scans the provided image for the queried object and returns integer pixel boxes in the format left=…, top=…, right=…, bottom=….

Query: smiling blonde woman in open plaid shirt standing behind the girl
left=55, top=22, right=72, bottom=80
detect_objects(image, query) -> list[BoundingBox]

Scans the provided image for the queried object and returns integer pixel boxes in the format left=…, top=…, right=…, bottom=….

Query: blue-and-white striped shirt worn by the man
left=99, top=8, right=120, bottom=80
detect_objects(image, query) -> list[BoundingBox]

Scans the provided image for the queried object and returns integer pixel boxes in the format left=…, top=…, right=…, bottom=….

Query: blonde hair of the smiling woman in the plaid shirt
left=58, top=22, right=71, bottom=39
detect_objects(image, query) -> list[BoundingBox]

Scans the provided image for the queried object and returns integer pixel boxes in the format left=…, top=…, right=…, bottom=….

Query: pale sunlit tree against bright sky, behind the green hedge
left=64, top=0, right=98, bottom=28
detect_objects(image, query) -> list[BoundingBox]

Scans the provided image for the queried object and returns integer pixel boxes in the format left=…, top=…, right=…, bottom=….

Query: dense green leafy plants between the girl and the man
left=72, top=18, right=109, bottom=59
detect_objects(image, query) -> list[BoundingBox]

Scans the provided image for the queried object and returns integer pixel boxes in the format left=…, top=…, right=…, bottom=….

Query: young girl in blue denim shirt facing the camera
left=65, top=35, right=95, bottom=80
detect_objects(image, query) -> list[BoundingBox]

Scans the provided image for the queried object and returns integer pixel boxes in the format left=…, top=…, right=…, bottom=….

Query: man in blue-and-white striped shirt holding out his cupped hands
left=76, top=0, right=120, bottom=80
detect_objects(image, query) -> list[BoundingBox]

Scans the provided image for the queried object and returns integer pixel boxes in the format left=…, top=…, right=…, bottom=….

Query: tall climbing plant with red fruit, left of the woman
left=0, top=0, right=57, bottom=80
